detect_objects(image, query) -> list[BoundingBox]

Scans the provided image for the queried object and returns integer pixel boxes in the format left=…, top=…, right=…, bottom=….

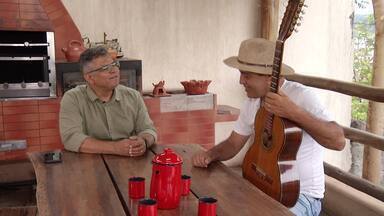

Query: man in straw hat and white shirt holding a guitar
left=192, top=38, right=345, bottom=215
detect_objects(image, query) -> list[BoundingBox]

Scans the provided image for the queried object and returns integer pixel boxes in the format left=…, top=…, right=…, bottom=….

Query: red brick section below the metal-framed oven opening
left=0, top=99, right=63, bottom=160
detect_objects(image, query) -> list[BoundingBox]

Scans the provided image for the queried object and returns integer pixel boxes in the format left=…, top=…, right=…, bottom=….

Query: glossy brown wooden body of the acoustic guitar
left=242, top=107, right=302, bottom=207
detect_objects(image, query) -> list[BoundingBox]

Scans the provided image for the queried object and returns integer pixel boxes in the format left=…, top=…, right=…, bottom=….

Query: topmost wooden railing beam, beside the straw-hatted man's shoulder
left=285, top=74, right=384, bottom=102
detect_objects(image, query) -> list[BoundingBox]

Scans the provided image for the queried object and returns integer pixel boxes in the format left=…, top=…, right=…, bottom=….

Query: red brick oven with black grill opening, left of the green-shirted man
left=0, top=0, right=81, bottom=160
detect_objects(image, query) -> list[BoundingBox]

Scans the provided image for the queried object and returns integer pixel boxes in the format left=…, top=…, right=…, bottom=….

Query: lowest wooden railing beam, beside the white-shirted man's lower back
left=324, top=162, right=384, bottom=202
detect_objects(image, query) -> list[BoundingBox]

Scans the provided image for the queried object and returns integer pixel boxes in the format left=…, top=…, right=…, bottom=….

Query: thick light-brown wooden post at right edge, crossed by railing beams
left=363, top=0, right=384, bottom=184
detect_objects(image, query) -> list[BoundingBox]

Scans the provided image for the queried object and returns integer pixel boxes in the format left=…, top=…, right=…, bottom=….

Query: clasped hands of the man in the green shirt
left=115, top=136, right=147, bottom=157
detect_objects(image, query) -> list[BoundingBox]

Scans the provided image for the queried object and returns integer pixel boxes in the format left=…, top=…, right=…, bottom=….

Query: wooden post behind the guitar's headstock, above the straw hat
left=261, top=0, right=280, bottom=41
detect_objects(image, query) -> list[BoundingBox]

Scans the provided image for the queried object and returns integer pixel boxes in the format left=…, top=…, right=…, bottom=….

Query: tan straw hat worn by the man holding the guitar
left=224, top=38, right=295, bottom=75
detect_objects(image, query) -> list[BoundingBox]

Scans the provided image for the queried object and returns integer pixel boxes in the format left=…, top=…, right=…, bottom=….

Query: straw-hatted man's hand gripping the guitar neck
left=264, top=91, right=301, bottom=121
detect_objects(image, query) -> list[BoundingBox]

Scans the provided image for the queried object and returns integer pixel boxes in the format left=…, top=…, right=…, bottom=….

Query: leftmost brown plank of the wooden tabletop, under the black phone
left=29, top=152, right=125, bottom=216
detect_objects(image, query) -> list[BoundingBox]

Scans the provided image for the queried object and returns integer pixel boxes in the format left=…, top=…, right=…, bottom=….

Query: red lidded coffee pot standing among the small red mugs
left=150, top=148, right=183, bottom=209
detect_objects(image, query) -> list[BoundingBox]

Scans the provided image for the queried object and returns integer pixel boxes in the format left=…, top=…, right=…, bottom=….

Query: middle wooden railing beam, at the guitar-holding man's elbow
left=343, top=126, right=384, bottom=151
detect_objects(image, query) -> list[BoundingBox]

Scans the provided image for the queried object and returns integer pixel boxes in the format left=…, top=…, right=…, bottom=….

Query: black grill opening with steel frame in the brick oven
left=0, top=31, right=56, bottom=98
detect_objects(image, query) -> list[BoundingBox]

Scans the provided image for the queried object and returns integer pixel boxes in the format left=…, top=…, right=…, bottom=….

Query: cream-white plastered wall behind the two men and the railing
left=62, top=0, right=352, bottom=168
